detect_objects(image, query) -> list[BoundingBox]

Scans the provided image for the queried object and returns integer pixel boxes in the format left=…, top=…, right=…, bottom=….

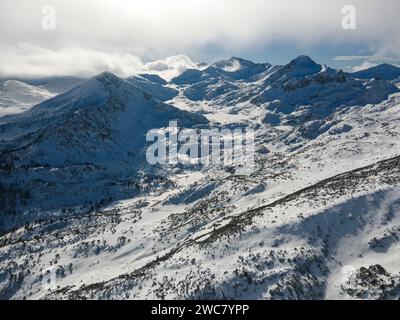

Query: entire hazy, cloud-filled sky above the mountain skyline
left=0, top=0, right=400, bottom=76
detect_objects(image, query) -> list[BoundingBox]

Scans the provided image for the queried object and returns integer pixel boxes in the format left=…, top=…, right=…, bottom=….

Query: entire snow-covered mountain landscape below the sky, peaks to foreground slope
left=0, top=56, right=400, bottom=299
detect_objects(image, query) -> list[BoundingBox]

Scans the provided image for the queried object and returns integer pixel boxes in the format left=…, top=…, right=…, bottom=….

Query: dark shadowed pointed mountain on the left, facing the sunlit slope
left=0, top=73, right=207, bottom=229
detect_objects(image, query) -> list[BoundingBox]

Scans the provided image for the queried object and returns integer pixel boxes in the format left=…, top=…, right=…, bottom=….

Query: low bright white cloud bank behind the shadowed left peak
left=0, top=43, right=196, bottom=79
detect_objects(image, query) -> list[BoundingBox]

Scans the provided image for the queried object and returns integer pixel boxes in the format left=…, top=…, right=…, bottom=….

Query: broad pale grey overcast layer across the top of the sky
left=0, top=0, right=400, bottom=50
